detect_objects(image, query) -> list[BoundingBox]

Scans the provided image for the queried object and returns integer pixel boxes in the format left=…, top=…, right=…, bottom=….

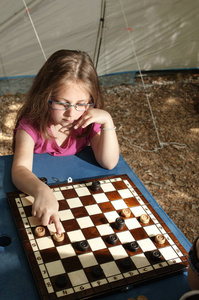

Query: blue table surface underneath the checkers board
left=0, top=147, right=191, bottom=300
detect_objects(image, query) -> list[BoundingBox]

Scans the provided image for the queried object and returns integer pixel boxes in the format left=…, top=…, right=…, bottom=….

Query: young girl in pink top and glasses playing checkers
left=12, top=50, right=119, bottom=234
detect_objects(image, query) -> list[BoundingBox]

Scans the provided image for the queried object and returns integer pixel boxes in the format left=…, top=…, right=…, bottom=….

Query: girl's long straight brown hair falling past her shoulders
left=16, top=50, right=104, bottom=138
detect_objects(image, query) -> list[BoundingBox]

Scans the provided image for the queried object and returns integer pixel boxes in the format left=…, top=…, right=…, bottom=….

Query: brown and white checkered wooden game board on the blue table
left=7, top=175, right=188, bottom=300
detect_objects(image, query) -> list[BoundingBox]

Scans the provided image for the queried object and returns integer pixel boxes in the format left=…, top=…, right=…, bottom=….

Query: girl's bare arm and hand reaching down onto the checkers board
left=12, top=130, right=61, bottom=233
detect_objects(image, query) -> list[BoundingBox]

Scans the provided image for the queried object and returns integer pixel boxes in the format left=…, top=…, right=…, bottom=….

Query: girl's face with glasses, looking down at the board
left=51, top=83, right=91, bottom=127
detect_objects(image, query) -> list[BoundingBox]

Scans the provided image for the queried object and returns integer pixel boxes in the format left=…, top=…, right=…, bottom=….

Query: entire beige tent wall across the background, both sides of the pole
left=0, top=0, right=199, bottom=78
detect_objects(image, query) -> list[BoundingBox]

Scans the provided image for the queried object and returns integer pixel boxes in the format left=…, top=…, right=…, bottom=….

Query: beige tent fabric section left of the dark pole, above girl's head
left=0, top=0, right=101, bottom=77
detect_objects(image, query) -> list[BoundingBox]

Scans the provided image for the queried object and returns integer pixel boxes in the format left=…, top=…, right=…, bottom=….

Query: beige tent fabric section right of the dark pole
left=98, top=0, right=199, bottom=74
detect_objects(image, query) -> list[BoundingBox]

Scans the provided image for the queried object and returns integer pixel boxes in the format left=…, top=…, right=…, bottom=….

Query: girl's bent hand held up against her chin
left=74, top=108, right=114, bottom=129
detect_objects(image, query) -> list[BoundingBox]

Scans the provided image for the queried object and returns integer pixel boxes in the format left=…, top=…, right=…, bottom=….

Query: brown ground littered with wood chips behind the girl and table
left=0, top=73, right=199, bottom=243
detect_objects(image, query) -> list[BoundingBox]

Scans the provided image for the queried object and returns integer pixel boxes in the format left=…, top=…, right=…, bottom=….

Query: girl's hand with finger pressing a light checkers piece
left=32, top=186, right=61, bottom=234
